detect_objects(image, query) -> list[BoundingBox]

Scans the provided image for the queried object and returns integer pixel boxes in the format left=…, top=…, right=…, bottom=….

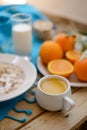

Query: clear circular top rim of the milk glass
left=11, top=13, right=32, bottom=22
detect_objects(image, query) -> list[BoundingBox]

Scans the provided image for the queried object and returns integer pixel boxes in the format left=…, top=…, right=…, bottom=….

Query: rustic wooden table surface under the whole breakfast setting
left=0, top=17, right=87, bottom=130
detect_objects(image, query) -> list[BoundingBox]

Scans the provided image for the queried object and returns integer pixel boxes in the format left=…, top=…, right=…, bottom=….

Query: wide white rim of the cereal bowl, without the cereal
left=0, top=54, right=37, bottom=102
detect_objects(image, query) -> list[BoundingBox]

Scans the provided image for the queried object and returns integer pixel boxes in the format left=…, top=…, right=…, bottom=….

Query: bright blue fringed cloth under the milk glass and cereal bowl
left=0, top=4, right=47, bottom=122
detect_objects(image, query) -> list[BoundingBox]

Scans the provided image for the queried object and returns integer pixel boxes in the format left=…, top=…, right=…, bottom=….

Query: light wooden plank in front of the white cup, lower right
left=20, top=88, right=87, bottom=130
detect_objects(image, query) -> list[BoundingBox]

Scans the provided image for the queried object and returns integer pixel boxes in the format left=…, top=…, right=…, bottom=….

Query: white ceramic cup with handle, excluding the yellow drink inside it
left=36, top=75, right=75, bottom=113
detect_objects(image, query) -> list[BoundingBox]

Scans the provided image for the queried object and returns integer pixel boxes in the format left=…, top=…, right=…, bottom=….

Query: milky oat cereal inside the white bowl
left=0, top=63, right=25, bottom=95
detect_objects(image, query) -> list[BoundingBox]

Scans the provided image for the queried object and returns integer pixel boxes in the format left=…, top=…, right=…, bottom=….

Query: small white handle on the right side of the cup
left=63, top=96, right=75, bottom=116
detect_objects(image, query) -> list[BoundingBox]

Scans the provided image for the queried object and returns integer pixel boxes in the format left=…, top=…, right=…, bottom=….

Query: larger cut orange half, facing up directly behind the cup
left=47, top=59, right=74, bottom=77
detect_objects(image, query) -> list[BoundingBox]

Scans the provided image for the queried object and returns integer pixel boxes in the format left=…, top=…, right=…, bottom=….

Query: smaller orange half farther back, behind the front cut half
left=65, top=50, right=82, bottom=63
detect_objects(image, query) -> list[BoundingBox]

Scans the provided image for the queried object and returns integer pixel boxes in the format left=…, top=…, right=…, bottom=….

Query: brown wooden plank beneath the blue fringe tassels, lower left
left=0, top=90, right=44, bottom=130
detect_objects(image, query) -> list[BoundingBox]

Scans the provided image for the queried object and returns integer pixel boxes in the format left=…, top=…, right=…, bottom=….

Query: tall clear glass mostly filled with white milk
left=12, top=13, right=32, bottom=59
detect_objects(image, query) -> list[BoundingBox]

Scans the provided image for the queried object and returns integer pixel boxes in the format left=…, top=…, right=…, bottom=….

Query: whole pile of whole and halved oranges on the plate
left=39, top=33, right=87, bottom=81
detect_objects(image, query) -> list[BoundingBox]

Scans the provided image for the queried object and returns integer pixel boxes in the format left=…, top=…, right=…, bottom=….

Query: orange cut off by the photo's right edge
left=74, top=58, right=87, bottom=81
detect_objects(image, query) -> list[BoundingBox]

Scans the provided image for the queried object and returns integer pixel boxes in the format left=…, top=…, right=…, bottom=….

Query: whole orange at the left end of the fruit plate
left=40, top=41, right=63, bottom=65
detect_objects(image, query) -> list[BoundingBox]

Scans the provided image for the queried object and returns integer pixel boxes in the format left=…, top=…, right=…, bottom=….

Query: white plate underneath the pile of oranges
left=37, top=57, right=87, bottom=87
